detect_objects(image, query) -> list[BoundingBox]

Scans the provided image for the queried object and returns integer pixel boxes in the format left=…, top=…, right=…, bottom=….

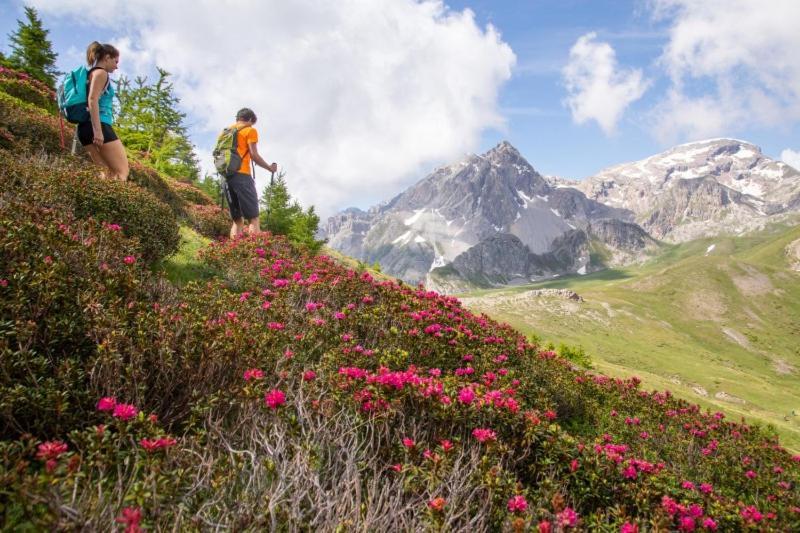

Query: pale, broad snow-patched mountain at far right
left=577, top=139, right=800, bottom=242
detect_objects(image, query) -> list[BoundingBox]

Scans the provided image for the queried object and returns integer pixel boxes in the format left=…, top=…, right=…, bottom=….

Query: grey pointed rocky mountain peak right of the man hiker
left=322, top=142, right=634, bottom=283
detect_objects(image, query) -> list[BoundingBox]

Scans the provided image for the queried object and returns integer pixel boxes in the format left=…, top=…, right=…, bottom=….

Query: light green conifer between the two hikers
left=114, top=67, right=200, bottom=181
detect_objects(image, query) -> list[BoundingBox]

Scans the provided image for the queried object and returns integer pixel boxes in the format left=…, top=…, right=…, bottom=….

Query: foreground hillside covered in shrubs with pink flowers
left=0, top=67, right=800, bottom=532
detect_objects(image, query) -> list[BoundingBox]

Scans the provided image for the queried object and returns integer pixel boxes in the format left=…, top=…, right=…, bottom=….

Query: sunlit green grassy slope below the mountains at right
left=464, top=221, right=800, bottom=449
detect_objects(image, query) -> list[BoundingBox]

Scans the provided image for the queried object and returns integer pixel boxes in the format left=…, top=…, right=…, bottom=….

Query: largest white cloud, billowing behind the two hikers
left=32, top=0, right=515, bottom=214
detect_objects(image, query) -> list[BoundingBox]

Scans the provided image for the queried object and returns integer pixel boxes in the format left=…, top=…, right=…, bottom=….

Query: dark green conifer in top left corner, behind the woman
left=7, top=6, right=60, bottom=89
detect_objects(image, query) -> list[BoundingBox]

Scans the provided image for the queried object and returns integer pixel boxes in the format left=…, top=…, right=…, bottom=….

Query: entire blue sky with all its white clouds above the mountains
left=0, top=0, right=800, bottom=214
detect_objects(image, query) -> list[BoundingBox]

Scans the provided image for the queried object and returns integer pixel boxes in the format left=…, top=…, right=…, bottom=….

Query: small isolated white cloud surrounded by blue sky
left=562, top=32, right=649, bottom=134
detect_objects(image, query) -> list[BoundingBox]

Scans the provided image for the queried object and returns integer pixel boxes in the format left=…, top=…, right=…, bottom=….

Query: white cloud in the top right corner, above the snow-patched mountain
left=651, top=0, right=800, bottom=141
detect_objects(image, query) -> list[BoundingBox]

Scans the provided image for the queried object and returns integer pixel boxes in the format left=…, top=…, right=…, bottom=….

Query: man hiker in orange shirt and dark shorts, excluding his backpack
left=222, top=107, right=278, bottom=239
